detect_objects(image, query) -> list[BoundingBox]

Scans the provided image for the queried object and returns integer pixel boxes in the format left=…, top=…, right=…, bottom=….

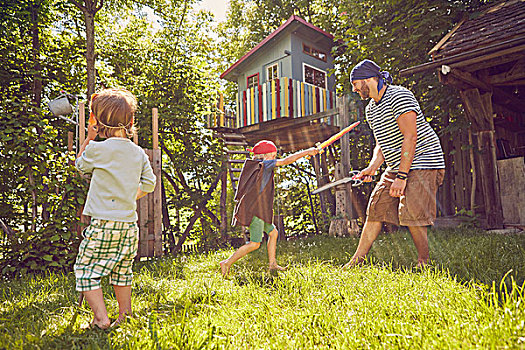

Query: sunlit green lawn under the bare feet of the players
left=0, top=230, right=525, bottom=349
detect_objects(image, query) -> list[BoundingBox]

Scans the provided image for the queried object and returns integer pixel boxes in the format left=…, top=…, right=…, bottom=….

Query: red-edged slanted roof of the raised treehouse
left=221, top=15, right=334, bottom=81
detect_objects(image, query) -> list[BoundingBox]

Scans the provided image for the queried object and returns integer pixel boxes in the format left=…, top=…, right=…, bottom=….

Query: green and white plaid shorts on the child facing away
left=74, top=218, right=139, bottom=292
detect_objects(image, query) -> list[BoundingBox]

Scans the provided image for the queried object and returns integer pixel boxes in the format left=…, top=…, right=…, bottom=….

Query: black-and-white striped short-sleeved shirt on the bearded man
left=366, top=85, right=445, bottom=171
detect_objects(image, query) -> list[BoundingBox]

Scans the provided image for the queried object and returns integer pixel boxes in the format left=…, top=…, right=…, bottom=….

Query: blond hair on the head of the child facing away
left=89, top=89, right=137, bottom=138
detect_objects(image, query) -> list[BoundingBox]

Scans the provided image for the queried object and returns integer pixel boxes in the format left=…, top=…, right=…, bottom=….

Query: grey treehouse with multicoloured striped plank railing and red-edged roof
left=212, top=16, right=339, bottom=152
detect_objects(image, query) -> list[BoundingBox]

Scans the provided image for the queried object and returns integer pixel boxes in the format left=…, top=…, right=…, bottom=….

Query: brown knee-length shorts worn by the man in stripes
left=366, top=169, right=445, bottom=226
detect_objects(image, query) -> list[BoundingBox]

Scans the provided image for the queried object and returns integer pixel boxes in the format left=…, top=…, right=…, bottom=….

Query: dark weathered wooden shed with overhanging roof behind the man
left=400, top=0, right=525, bottom=228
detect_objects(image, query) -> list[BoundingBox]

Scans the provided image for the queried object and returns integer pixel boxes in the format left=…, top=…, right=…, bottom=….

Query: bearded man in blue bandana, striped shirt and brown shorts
left=343, top=60, right=445, bottom=268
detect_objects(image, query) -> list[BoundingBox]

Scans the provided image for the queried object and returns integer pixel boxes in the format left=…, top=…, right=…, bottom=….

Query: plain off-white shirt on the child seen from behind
left=75, top=137, right=157, bottom=222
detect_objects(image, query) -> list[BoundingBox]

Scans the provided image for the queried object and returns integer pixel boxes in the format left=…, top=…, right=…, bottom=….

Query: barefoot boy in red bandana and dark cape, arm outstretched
left=220, top=140, right=319, bottom=277
